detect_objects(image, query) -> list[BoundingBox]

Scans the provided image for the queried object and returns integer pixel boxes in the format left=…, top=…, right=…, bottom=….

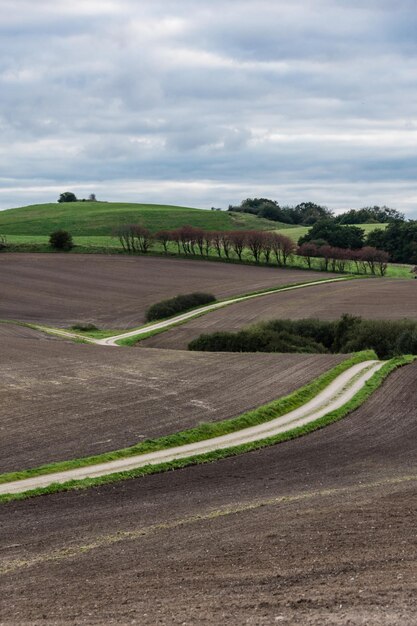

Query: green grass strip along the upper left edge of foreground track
left=0, top=350, right=377, bottom=484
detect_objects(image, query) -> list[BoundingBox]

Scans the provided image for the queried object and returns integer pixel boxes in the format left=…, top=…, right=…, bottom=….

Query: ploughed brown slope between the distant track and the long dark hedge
left=140, top=278, right=417, bottom=349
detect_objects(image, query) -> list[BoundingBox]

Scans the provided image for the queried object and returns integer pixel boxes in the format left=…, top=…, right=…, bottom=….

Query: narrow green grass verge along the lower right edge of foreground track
left=0, top=355, right=417, bottom=503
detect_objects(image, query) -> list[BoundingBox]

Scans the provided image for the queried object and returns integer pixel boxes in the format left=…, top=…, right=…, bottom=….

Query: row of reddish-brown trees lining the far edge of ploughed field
left=113, top=224, right=389, bottom=275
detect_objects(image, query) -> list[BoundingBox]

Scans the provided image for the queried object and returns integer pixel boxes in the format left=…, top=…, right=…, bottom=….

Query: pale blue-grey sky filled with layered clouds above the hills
left=0, top=0, right=417, bottom=218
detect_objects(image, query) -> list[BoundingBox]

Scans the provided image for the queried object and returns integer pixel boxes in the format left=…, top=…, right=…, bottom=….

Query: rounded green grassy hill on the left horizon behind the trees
left=0, top=202, right=286, bottom=236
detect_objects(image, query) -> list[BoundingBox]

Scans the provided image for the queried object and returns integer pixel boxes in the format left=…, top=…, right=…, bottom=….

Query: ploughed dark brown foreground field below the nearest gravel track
left=0, top=364, right=417, bottom=626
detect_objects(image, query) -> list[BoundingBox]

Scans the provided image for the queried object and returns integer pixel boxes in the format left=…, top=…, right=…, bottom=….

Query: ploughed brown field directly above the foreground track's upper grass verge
left=0, top=324, right=346, bottom=472
